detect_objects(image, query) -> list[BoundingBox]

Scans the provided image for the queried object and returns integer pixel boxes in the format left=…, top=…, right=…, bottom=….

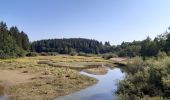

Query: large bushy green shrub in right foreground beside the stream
left=117, top=57, right=170, bottom=100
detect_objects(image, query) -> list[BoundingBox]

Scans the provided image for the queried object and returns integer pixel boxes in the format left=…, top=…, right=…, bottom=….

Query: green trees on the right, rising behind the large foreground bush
left=113, top=28, right=170, bottom=59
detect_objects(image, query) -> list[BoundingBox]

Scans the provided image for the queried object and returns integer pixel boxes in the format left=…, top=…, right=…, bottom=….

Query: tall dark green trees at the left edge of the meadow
left=0, top=22, right=30, bottom=58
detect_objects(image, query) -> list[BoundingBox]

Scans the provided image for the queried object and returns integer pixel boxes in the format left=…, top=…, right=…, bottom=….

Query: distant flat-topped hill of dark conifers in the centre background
left=31, top=38, right=113, bottom=54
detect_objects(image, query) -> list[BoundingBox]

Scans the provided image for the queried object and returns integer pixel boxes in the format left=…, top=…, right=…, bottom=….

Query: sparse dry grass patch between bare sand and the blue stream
left=8, top=68, right=96, bottom=100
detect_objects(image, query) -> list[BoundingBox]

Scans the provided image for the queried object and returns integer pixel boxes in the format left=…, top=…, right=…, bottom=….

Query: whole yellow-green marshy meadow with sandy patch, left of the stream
left=0, top=55, right=113, bottom=100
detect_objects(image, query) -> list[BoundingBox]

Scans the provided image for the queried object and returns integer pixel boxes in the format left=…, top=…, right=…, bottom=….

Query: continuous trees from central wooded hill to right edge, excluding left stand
left=31, top=28, right=170, bottom=59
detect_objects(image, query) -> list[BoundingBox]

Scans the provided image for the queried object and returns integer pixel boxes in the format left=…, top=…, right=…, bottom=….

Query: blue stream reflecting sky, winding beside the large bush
left=56, top=68, right=125, bottom=100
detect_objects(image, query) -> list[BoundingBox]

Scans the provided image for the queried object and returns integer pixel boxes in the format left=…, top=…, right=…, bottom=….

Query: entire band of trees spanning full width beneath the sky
left=0, top=22, right=170, bottom=59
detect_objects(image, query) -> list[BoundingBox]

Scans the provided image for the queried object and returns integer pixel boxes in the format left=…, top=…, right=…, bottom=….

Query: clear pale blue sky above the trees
left=0, top=0, right=170, bottom=44
